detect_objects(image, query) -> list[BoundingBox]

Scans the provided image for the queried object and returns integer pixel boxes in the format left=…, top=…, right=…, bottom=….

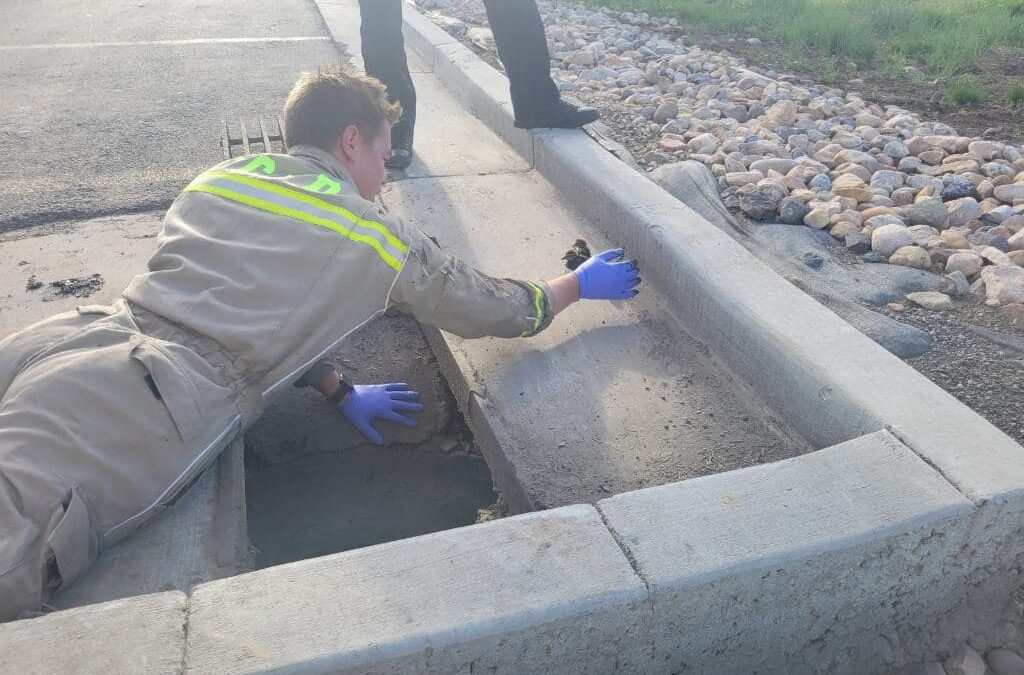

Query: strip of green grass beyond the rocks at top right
left=587, top=0, right=1024, bottom=78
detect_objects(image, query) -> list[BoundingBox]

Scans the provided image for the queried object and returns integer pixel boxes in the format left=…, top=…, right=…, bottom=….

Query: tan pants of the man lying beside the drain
left=0, top=302, right=241, bottom=621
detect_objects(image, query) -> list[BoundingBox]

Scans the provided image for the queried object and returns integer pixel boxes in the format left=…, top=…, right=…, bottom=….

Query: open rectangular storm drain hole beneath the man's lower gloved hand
left=245, top=315, right=505, bottom=568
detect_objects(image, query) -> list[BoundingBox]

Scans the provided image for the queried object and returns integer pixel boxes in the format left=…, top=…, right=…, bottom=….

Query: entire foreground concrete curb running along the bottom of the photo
left=0, top=431, right=1007, bottom=675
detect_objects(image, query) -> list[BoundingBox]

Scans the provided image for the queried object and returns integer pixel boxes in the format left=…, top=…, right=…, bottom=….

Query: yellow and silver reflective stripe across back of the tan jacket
left=185, top=171, right=409, bottom=270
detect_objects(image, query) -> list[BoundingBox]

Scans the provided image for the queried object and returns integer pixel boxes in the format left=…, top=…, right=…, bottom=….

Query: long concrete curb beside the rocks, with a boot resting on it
left=404, top=5, right=1024, bottom=503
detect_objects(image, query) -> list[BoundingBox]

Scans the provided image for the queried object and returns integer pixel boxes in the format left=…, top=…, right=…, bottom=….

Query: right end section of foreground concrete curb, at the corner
left=598, top=431, right=983, bottom=674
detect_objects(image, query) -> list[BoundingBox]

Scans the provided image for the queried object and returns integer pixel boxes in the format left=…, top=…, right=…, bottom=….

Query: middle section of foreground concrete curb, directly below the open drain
left=186, top=506, right=650, bottom=675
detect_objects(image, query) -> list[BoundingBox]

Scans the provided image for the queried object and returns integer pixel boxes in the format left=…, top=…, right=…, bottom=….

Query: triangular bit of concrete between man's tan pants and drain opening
left=49, top=440, right=254, bottom=608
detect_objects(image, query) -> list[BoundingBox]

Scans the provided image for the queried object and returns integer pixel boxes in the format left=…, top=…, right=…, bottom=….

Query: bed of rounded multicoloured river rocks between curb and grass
left=428, top=0, right=1024, bottom=321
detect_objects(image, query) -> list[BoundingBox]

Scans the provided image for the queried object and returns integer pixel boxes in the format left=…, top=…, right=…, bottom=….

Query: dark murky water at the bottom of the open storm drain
left=246, top=448, right=496, bottom=568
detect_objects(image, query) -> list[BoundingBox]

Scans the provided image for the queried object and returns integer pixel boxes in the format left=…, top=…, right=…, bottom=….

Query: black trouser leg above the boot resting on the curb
left=483, top=0, right=559, bottom=117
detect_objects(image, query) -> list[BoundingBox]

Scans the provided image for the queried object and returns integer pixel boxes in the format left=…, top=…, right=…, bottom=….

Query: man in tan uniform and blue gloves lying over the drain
left=0, top=70, right=640, bottom=620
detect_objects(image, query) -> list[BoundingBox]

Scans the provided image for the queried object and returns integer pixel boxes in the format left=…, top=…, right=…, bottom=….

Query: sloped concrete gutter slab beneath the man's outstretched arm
left=384, top=173, right=809, bottom=510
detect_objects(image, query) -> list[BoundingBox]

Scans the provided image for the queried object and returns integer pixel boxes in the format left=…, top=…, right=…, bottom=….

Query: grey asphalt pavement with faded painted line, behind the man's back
left=0, top=0, right=341, bottom=233
